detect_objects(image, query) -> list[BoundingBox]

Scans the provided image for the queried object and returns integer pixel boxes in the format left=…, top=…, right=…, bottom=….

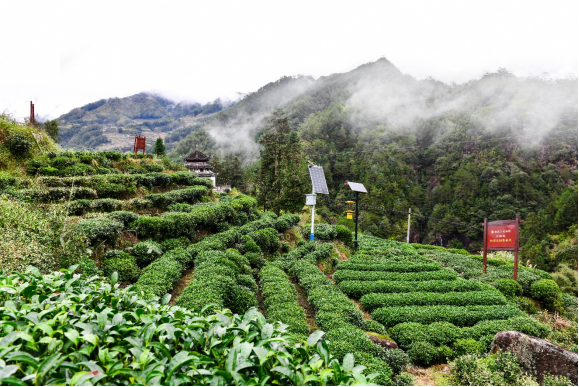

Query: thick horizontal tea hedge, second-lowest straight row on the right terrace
left=372, top=304, right=525, bottom=327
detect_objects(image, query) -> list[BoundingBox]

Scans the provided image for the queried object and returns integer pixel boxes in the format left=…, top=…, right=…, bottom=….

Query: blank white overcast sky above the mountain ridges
left=0, top=0, right=579, bottom=120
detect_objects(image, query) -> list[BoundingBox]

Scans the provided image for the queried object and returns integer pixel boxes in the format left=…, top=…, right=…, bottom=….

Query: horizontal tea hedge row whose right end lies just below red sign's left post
left=338, top=278, right=491, bottom=299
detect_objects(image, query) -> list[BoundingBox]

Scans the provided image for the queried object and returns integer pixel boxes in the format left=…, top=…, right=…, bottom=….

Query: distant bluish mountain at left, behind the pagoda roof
left=58, top=93, right=232, bottom=151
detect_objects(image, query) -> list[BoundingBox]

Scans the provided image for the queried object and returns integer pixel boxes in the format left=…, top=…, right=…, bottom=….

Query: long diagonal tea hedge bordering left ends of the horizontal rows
left=290, top=260, right=393, bottom=385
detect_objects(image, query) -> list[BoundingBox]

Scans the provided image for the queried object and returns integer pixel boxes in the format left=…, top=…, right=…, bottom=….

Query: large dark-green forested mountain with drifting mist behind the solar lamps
left=172, top=59, right=578, bottom=272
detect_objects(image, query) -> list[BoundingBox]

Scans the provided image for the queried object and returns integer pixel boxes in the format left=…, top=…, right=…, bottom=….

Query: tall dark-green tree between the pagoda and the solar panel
left=257, top=110, right=307, bottom=215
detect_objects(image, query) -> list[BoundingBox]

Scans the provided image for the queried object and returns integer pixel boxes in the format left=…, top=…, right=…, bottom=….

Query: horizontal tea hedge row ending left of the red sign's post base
left=334, top=269, right=458, bottom=283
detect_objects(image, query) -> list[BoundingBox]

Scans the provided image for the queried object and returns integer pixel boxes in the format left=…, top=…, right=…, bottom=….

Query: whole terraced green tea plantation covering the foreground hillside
left=0, top=146, right=577, bottom=385
